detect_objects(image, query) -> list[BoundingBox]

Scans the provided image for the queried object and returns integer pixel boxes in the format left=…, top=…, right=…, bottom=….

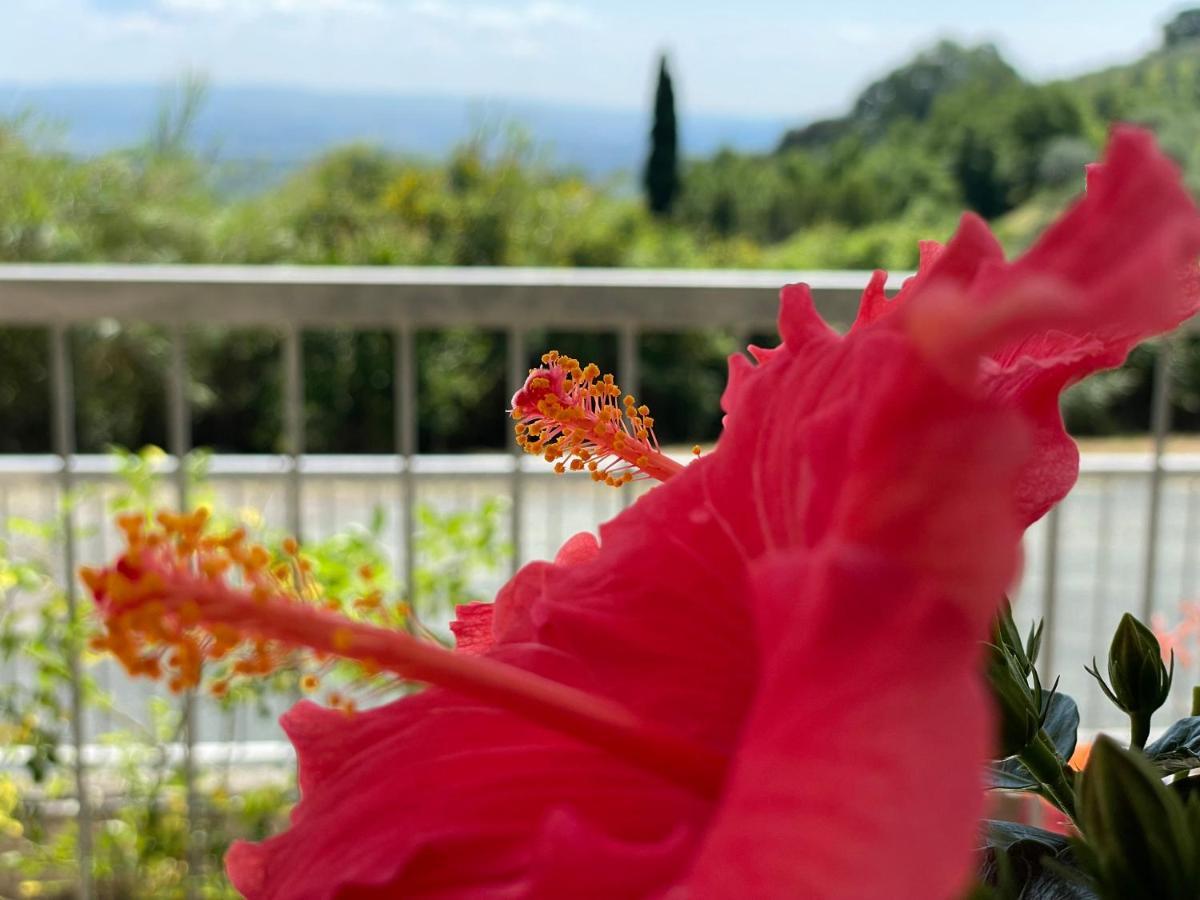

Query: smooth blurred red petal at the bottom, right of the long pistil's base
left=686, top=557, right=990, bottom=900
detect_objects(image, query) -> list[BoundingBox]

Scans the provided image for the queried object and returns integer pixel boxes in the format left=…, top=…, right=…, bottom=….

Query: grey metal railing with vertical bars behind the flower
left=0, top=265, right=1185, bottom=898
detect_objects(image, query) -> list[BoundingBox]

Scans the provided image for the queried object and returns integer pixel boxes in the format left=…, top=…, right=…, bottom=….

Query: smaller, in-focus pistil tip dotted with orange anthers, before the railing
left=511, top=350, right=683, bottom=487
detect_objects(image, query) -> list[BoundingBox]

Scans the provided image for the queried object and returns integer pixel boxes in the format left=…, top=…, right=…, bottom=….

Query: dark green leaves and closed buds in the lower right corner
left=970, top=606, right=1200, bottom=900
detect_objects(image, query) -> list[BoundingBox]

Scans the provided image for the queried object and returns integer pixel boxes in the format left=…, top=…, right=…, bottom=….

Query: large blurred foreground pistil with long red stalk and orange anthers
left=83, top=516, right=726, bottom=796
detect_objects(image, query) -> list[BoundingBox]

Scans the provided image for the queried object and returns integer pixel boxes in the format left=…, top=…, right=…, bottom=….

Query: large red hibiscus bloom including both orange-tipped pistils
left=85, top=131, right=1200, bottom=899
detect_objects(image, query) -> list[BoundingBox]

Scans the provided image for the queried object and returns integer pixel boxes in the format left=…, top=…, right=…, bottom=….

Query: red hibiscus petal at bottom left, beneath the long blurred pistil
left=227, top=672, right=707, bottom=900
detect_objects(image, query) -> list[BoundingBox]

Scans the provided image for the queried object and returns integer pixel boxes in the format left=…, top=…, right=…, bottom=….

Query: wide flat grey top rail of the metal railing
left=0, top=265, right=905, bottom=331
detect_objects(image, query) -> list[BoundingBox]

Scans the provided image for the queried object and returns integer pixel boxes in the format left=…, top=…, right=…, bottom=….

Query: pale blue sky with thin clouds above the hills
left=0, top=0, right=1178, bottom=118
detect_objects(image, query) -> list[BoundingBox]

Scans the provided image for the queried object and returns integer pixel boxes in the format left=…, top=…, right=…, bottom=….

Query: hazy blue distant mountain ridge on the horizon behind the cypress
left=0, top=84, right=787, bottom=184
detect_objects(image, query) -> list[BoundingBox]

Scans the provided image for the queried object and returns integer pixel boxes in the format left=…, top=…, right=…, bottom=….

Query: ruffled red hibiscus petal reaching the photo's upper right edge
left=844, top=127, right=1200, bottom=523
